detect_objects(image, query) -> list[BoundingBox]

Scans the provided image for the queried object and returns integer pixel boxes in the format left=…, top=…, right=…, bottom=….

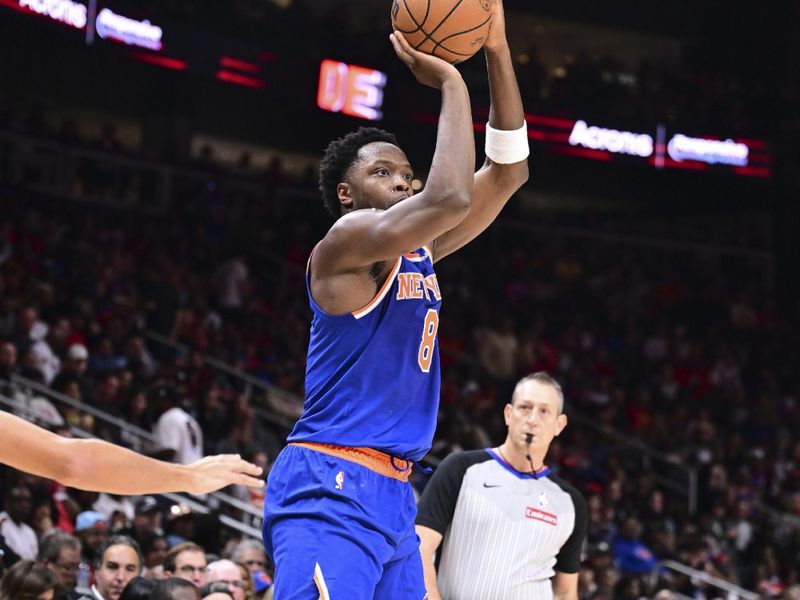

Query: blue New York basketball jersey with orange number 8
left=288, top=248, right=442, bottom=460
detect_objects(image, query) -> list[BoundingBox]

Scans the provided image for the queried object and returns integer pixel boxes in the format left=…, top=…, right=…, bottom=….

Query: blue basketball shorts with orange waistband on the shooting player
left=262, top=444, right=425, bottom=600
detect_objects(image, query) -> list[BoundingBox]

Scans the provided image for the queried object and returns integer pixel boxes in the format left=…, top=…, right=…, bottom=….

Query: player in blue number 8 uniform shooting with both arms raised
left=263, top=1, right=528, bottom=600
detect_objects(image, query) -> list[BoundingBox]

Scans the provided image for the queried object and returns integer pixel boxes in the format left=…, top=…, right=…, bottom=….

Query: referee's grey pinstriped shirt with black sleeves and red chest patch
left=416, top=449, right=586, bottom=600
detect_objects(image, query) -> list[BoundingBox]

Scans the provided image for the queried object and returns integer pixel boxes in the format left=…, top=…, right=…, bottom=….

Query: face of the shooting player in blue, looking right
left=339, top=142, right=414, bottom=210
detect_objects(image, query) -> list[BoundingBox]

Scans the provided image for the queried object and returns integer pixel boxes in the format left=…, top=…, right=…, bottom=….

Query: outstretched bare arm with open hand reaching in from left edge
left=0, top=411, right=264, bottom=495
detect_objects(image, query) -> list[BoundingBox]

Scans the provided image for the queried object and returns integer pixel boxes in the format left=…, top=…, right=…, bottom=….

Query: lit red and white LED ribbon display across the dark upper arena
left=0, top=0, right=773, bottom=179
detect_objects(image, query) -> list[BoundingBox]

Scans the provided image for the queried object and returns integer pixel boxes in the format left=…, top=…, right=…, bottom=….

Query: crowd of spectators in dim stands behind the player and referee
left=0, top=125, right=800, bottom=600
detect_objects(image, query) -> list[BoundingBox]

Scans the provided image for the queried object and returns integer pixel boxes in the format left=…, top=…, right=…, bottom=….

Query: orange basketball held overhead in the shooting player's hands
left=392, top=0, right=492, bottom=64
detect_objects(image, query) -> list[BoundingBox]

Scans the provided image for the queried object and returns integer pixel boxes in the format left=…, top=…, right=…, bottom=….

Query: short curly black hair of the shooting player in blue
left=319, top=127, right=398, bottom=219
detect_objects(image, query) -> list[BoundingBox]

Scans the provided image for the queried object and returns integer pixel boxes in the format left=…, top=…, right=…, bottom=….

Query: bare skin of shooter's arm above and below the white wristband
left=433, top=0, right=528, bottom=260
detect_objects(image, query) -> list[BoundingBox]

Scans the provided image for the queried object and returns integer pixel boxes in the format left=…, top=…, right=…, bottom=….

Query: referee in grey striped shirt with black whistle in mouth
left=416, top=373, right=586, bottom=600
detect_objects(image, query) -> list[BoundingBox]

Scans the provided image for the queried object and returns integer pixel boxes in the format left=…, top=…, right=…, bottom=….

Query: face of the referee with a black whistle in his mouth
left=504, top=380, right=567, bottom=452
